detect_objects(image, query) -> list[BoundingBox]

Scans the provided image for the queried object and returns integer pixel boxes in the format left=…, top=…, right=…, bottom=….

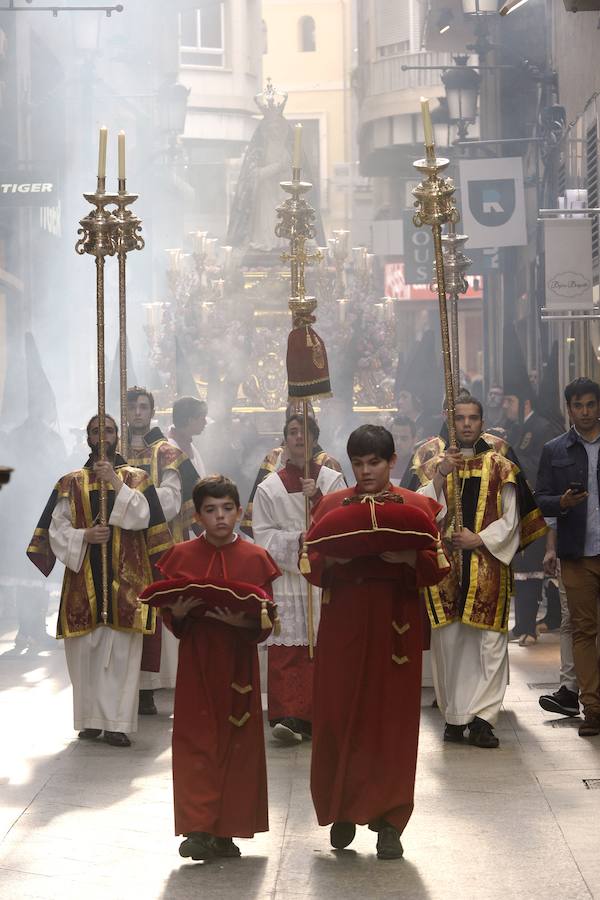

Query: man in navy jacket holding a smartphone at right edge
left=536, top=378, right=600, bottom=737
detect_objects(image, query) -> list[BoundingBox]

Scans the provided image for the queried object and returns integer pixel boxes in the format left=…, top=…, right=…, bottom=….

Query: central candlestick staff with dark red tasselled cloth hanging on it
left=275, top=125, right=331, bottom=659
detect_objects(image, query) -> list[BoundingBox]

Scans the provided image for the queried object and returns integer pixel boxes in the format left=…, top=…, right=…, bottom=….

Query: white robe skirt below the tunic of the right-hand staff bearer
left=431, top=622, right=508, bottom=725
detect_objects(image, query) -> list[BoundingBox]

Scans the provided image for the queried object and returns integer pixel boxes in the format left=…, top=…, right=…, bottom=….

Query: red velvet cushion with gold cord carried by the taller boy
left=306, top=495, right=439, bottom=559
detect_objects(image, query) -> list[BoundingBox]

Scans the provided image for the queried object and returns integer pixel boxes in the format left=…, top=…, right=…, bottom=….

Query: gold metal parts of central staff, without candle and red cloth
left=275, top=168, right=323, bottom=659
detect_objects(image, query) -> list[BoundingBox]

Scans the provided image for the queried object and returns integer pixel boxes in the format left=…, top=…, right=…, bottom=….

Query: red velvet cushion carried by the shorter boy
left=140, top=578, right=277, bottom=622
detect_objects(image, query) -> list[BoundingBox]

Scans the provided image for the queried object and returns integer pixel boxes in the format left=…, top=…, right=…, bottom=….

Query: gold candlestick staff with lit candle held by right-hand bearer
left=413, top=98, right=463, bottom=540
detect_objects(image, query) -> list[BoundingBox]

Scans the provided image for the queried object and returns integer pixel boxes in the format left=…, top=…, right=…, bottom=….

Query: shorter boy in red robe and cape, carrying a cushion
left=159, top=475, right=281, bottom=859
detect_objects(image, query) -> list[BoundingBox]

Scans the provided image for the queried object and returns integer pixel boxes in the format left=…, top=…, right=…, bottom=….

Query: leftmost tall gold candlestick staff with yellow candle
left=75, top=128, right=117, bottom=623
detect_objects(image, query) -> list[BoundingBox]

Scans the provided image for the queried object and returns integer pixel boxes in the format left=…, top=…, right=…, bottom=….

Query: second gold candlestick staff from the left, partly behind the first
left=114, top=131, right=144, bottom=460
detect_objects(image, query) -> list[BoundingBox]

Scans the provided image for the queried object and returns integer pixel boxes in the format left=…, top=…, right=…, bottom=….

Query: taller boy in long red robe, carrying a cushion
left=306, top=425, right=449, bottom=859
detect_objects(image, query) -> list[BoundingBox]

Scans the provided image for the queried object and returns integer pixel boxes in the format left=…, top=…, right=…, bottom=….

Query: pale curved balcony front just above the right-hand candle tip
left=357, top=51, right=453, bottom=99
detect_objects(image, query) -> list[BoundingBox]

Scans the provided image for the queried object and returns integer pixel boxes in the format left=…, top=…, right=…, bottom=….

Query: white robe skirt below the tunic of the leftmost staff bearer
left=65, top=625, right=142, bottom=733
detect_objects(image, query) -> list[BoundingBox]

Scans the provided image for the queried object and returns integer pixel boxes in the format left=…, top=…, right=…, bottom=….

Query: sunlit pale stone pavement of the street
left=0, top=620, right=600, bottom=900
